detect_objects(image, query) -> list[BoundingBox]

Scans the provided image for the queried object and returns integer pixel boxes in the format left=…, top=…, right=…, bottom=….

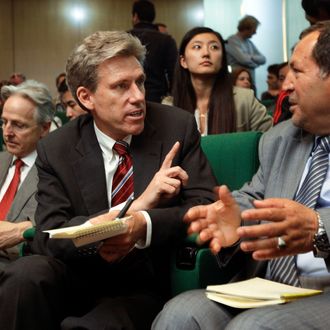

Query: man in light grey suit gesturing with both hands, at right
left=153, top=21, right=330, bottom=330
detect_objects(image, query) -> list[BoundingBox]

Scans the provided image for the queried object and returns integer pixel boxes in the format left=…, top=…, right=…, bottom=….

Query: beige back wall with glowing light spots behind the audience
left=0, top=0, right=203, bottom=94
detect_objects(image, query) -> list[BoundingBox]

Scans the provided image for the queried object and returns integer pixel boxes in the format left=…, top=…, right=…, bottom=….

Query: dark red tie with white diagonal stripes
left=111, top=141, right=134, bottom=207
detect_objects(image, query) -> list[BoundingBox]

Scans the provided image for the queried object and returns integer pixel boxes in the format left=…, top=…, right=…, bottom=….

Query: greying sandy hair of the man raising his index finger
left=66, top=31, right=146, bottom=106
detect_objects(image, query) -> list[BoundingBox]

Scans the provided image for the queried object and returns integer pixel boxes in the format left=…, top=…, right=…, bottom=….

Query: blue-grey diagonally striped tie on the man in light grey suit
left=270, top=136, right=330, bottom=286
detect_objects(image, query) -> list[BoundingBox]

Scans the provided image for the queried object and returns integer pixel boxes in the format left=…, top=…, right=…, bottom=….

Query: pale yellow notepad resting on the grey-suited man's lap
left=206, top=277, right=322, bottom=308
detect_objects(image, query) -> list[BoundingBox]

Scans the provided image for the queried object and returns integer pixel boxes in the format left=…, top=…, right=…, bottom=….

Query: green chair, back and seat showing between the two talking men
left=171, top=132, right=261, bottom=296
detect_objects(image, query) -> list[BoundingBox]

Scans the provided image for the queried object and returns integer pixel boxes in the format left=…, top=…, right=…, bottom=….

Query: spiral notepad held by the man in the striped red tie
left=44, top=216, right=132, bottom=247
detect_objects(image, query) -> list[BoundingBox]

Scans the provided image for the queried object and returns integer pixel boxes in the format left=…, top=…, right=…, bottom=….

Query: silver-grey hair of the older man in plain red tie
left=1, top=80, right=55, bottom=125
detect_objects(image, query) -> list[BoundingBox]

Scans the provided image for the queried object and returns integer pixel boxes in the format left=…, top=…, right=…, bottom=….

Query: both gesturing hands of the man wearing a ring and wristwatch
left=184, top=186, right=318, bottom=260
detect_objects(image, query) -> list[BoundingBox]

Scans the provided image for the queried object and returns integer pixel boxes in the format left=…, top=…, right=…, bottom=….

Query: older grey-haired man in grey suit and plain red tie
left=0, top=80, right=54, bottom=269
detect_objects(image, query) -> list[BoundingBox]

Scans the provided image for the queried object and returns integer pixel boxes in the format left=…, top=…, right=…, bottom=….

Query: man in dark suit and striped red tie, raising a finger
left=0, top=31, right=215, bottom=330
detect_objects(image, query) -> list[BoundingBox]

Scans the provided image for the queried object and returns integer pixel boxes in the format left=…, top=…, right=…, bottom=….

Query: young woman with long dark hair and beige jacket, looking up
left=163, top=27, right=272, bottom=135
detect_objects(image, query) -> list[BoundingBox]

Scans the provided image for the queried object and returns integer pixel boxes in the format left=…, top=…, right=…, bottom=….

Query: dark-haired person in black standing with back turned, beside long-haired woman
left=130, top=0, right=178, bottom=102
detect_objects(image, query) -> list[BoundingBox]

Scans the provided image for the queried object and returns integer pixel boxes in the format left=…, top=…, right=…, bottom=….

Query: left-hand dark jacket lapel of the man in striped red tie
left=71, top=120, right=109, bottom=215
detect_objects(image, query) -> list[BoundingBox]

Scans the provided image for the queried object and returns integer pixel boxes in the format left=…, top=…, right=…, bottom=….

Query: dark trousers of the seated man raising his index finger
left=0, top=256, right=162, bottom=330
